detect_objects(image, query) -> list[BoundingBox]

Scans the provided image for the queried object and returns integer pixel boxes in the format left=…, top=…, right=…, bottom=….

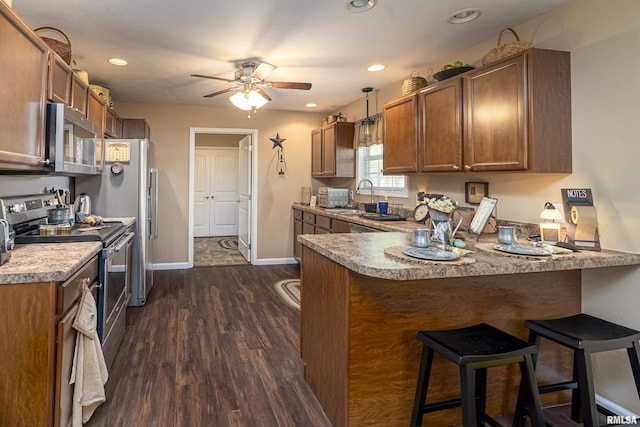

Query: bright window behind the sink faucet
left=358, top=144, right=408, bottom=197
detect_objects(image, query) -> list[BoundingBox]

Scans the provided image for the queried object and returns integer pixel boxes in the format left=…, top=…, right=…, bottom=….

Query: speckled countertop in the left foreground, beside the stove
left=0, top=242, right=102, bottom=286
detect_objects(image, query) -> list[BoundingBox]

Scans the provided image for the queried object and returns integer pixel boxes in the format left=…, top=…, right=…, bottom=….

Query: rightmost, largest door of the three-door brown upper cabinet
left=464, top=55, right=529, bottom=172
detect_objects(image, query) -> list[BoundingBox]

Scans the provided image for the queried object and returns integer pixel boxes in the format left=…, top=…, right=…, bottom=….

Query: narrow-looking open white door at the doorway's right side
left=238, top=135, right=251, bottom=262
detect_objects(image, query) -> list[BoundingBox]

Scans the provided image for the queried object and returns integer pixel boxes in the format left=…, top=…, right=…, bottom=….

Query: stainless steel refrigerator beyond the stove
left=76, top=139, right=158, bottom=306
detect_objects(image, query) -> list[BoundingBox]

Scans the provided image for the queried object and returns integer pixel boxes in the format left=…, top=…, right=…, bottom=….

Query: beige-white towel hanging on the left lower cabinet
left=69, top=282, right=109, bottom=427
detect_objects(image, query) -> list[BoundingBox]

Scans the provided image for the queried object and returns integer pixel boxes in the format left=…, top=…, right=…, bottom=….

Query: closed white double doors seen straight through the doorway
left=194, top=148, right=238, bottom=237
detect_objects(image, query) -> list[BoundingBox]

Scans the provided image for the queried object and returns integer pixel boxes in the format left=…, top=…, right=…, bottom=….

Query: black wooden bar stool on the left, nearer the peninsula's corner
left=411, top=323, right=544, bottom=427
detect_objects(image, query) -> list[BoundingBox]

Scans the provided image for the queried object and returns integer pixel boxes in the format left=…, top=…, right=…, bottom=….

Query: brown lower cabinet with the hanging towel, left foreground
left=0, top=256, right=99, bottom=427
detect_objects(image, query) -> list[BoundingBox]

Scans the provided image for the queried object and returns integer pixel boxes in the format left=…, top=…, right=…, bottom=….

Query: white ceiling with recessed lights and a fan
left=13, top=0, right=568, bottom=112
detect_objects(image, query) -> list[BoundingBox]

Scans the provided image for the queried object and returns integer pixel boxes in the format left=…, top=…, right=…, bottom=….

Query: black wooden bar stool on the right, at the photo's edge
left=513, top=313, right=640, bottom=427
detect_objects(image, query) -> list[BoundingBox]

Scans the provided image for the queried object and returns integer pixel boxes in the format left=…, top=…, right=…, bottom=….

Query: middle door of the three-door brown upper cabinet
left=418, top=78, right=463, bottom=172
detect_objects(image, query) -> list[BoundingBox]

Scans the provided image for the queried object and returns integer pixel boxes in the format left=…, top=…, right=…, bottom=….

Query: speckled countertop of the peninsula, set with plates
left=298, top=232, right=640, bottom=280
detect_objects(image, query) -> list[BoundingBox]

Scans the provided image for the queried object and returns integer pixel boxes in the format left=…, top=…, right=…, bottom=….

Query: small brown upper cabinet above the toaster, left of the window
left=311, top=122, right=356, bottom=178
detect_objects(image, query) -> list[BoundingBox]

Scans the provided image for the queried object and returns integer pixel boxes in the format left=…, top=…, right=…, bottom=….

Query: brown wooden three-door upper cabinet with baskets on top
left=383, top=49, right=572, bottom=175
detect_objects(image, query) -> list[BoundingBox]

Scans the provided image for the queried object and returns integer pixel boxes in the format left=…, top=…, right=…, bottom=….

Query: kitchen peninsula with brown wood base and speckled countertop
left=298, top=232, right=640, bottom=427
